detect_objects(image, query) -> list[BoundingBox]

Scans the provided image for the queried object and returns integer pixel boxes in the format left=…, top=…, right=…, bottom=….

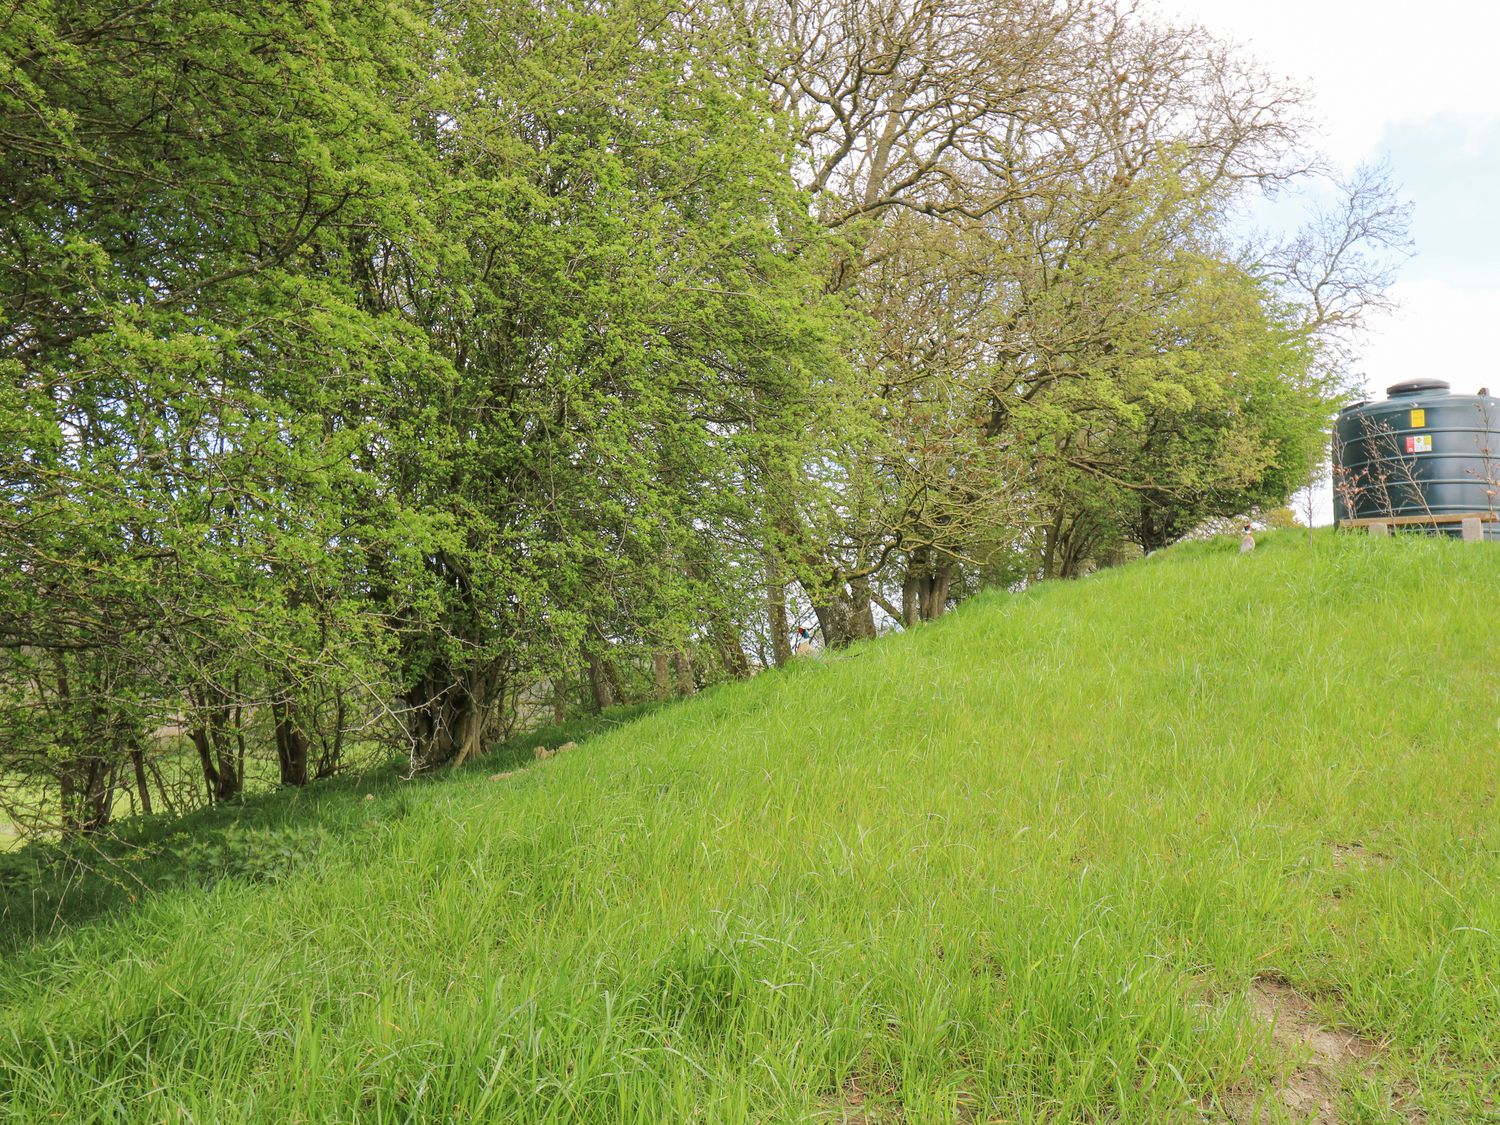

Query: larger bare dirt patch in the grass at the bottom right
left=1224, top=975, right=1425, bottom=1125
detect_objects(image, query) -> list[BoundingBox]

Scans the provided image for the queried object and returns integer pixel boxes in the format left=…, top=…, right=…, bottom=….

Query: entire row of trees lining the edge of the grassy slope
left=0, top=0, right=1403, bottom=833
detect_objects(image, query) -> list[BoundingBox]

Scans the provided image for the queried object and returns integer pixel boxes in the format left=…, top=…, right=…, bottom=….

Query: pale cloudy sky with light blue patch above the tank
left=1154, top=0, right=1500, bottom=522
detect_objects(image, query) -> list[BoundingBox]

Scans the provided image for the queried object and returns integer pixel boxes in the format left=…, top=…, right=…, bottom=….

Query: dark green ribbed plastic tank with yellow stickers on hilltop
left=1334, top=380, right=1500, bottom=539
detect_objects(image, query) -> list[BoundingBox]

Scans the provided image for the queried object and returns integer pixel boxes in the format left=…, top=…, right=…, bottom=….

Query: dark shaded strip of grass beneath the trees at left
left=0, top=704, right=665, bottom=954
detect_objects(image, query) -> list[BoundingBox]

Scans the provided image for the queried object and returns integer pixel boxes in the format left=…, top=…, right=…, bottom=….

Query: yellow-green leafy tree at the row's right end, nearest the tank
left=1014, top=254, right=1335, bottom=576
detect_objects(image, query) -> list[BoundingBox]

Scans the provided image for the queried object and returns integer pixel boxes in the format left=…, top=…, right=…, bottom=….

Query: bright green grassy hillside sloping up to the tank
left=0, top=533, right=1500, bottom=1124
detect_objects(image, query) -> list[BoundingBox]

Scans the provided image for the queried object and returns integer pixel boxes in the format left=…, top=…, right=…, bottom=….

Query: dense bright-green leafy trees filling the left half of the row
left=0, top=0, right=837, bottom=831
